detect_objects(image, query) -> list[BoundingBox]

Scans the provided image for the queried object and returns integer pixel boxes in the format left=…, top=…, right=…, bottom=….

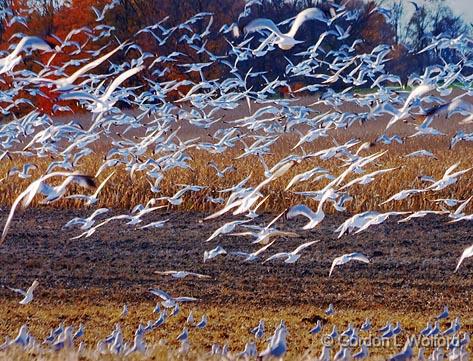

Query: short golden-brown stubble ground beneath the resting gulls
left=0, top=300, right=473, bottom=360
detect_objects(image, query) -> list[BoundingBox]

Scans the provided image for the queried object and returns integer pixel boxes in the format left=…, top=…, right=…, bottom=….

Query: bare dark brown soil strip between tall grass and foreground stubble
left=0, top=208, right=473, bottom=317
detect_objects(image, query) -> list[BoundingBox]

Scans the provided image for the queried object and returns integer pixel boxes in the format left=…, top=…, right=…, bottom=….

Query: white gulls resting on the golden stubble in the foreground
left=0, top=294, right=470, bottom=361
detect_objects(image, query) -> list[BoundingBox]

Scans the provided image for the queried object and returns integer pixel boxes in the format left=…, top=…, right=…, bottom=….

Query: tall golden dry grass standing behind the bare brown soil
left=0, top=126, right=473, bottom=213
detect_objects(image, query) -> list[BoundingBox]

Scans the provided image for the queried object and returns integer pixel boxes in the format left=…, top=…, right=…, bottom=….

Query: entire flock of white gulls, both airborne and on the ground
left=0, top=0, right=473, bottom=361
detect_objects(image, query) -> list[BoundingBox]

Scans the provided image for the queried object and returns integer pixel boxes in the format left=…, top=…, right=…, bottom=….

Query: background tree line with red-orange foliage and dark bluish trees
left=0, top=0, right=471, bottom=113
